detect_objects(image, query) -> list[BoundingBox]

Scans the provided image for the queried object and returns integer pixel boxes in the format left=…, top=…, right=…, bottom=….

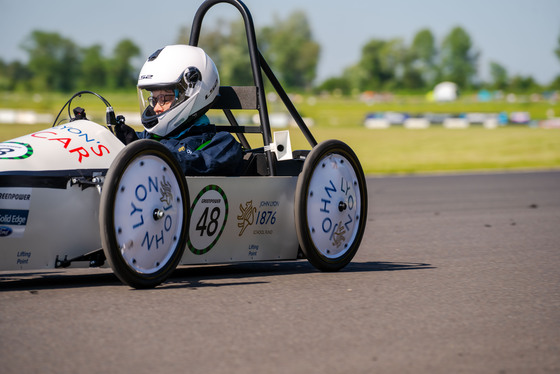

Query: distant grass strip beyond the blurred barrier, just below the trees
left=4, top=91, right=560, bottom=127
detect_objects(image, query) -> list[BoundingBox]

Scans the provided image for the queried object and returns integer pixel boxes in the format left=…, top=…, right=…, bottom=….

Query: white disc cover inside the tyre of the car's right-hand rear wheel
left=306, top=154, right=361, bottom=259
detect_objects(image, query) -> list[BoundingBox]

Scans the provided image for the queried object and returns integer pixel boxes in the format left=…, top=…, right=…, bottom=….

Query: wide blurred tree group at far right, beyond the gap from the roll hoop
left=319, top=26, right=560, bottom=94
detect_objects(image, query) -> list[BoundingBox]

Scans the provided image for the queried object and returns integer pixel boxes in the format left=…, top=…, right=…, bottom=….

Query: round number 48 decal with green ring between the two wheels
left=187, top=184, right=229, bottom=255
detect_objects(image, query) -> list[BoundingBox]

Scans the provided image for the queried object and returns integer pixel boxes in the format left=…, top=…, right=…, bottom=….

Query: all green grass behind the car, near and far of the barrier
left=0, top=93, right=560, bottom=174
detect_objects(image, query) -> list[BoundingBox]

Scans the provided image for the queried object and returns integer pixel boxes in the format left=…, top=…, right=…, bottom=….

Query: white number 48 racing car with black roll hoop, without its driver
left=0, top=0, right=368, bottom=288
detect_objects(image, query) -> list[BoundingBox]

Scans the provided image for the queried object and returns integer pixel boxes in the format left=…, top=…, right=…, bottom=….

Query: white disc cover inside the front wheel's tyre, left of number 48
left=114, top=155, right=184, bottom=274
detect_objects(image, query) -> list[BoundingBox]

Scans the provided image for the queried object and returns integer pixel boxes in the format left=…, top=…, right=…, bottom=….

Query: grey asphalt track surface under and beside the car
left=0, top=172, right=560, bottom=374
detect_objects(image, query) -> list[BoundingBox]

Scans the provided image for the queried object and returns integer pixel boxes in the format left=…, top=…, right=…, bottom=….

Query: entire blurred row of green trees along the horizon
left=0, top=11, right=560, bottom=94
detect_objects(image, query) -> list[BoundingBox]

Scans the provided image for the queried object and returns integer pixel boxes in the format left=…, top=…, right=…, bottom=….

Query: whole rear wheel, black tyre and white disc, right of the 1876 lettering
left=295, top=140, right=368, bottom=271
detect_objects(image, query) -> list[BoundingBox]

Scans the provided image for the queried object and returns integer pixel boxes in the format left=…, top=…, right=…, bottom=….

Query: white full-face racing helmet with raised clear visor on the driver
left=138, top=45, right=220, bottom=136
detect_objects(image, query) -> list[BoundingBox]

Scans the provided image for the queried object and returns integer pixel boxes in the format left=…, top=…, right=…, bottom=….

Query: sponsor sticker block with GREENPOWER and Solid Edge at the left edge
left=0, top=188, right=31, bottom=239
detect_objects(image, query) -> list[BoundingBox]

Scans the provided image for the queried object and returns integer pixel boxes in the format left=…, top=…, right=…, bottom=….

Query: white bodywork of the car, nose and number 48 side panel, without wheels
left=0, top=120, right=298, bottom=270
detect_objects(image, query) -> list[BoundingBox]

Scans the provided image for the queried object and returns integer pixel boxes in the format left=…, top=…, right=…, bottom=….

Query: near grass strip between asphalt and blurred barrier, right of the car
left=291, top=127, right=560, bottom=174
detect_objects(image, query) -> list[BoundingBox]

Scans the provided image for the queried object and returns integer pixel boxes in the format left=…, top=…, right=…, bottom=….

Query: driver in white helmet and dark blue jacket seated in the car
left=115, top=45, right=243, bottom=175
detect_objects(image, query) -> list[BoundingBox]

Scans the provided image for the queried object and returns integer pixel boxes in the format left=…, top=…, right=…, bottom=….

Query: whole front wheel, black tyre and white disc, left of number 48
left=99, top=140, right=189, bottom=288
